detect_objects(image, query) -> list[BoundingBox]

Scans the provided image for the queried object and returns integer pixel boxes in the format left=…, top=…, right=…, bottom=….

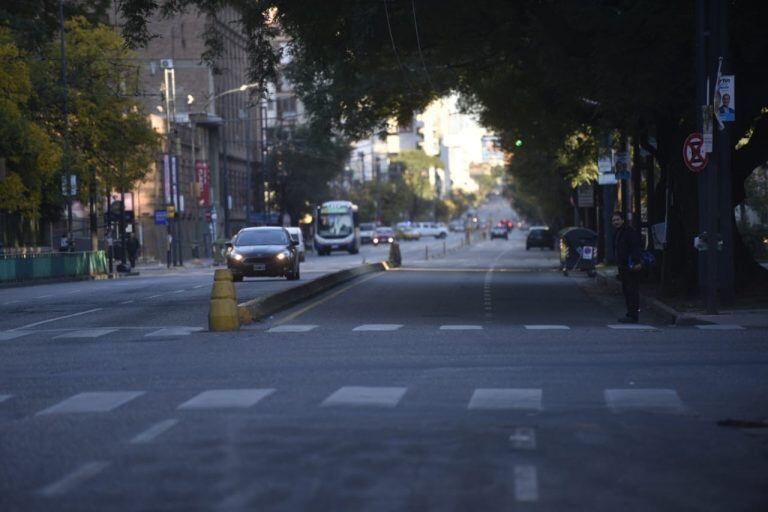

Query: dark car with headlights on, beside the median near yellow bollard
left=226, top=227, right=300, bottom=281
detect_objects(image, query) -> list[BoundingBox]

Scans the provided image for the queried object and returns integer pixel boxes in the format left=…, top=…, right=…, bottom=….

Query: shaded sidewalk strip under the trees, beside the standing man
left=596, top=267, right=768, bottom=327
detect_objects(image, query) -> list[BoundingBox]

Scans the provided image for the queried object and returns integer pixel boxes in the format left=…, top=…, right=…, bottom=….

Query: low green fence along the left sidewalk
left=0, top=251, right=107, bottom=283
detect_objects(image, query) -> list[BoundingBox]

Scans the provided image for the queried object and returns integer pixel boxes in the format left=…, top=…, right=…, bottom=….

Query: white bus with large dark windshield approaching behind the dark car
left=315, top=201, right=360, bottom=256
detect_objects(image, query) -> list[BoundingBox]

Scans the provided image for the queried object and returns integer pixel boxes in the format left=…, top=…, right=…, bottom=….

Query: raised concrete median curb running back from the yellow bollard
left=238, top=262, right=389, bottom=321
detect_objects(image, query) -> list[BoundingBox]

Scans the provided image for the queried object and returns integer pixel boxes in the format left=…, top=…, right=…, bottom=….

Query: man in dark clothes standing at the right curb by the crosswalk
left=611, top=212, right=643, bottom=324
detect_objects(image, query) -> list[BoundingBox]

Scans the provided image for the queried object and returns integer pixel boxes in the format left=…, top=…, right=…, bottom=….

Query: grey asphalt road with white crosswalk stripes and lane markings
left=0, top=219, right=768, bottom=511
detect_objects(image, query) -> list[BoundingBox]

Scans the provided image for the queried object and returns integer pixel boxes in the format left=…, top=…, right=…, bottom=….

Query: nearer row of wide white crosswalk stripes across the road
left=0, top=385, right=691, bottom=416
